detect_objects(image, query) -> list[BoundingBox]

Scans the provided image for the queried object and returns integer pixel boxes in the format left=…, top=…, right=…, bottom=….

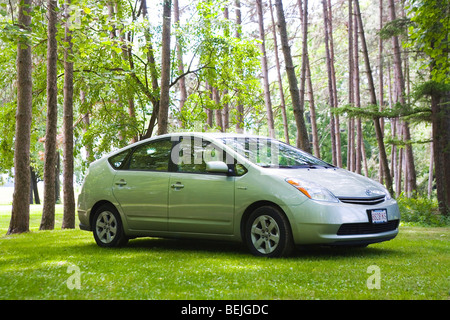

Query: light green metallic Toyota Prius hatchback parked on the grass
left=78, top=133, right=400, bottom=257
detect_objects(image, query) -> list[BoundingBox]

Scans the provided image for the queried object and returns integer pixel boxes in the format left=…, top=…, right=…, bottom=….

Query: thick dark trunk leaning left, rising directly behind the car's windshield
left=275, top=0, right=311, bottom=153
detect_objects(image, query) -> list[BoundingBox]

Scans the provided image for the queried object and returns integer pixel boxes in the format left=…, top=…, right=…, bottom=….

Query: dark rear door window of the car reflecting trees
left=128, top=139, right=172, bottom=171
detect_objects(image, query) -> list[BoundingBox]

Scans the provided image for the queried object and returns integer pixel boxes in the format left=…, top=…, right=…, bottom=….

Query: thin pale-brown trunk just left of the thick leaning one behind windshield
left=256, top=0, right=275, bottom=138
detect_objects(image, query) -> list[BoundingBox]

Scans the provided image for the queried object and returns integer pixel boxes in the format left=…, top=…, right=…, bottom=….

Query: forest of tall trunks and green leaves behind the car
left=0, top=0, right=450, bottom=233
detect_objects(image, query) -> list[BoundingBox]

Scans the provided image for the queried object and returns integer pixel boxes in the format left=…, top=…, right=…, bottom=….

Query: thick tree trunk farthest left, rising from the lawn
left=7, top=0, right=33, bottom=234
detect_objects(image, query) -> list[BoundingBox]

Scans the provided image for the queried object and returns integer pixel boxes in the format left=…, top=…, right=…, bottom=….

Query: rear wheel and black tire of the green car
left=93, top=204, right=128, bottom=248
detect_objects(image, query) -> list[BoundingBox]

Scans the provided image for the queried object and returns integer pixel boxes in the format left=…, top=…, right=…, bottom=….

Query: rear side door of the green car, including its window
left=113, top=139, right=172, bottom=231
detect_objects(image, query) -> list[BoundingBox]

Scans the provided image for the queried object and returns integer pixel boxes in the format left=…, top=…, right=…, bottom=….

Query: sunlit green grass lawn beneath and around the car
left=0, top=206, right=450, bottom=300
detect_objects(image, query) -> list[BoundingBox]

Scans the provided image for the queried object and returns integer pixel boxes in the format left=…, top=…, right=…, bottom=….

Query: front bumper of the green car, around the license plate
left=289, top=199, right=400, bottom=245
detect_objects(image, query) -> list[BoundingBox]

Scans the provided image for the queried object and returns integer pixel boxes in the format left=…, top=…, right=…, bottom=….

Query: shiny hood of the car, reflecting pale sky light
left=265, top=168, right=386, bottom=198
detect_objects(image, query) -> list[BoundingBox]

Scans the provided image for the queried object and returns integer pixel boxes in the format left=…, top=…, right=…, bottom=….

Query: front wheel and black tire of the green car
left=245, top=206, right=294, bottom=258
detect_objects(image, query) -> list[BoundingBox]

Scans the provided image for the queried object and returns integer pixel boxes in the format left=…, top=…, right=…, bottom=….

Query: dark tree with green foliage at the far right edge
left=409, top=0, right=450, bottom=216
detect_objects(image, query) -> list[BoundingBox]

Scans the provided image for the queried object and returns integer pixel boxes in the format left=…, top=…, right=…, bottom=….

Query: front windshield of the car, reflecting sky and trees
left=222, top=137, right=333, bottom=168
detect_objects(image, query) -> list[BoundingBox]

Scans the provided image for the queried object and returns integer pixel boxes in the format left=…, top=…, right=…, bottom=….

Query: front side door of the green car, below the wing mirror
left=169, top=137, right=235, bottom=234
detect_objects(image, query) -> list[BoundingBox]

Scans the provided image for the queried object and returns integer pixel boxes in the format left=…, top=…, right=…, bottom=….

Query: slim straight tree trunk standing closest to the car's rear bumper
left=62, top=0, right=75, bottom=229
